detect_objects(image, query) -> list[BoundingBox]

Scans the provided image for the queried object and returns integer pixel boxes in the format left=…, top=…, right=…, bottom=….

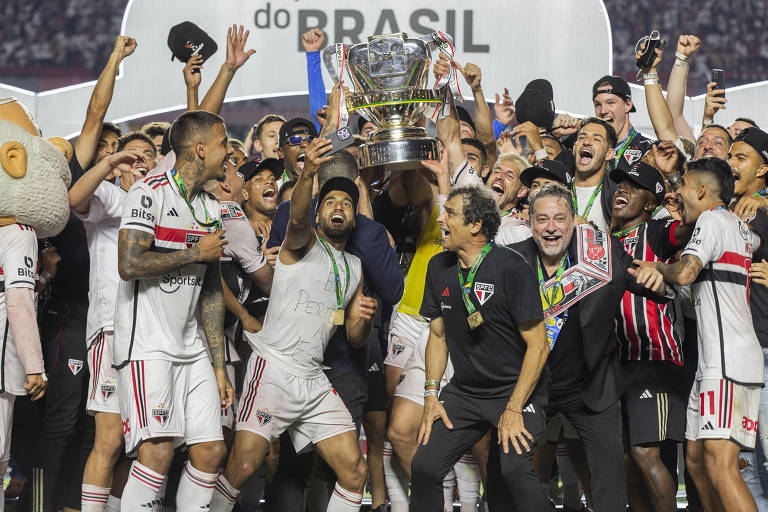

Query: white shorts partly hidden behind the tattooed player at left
left=85, top=331, right=120, bottom=414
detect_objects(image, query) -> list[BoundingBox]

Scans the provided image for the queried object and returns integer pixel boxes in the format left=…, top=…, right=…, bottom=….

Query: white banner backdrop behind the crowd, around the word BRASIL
left=0, top=0, right=768, bottom=137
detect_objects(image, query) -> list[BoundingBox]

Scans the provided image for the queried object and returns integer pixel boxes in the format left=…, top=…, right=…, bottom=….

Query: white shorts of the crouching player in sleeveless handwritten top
left=235, top=352, right=355, bottom=453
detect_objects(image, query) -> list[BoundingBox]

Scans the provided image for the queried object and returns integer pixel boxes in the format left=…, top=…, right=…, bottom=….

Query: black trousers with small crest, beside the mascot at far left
left=11, top=304, right=94, bottom=512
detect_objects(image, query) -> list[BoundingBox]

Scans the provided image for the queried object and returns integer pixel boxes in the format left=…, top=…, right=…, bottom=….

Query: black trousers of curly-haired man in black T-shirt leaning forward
left=411, top=384, right=551, bottom=512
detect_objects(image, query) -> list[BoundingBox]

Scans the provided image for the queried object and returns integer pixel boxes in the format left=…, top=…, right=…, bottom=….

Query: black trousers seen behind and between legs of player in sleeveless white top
left=266, top=369, right=367, bottom=512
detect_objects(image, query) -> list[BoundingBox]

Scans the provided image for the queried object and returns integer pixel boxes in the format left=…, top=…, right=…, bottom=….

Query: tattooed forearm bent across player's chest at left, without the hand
left=117, top=229, right=200, bottom=281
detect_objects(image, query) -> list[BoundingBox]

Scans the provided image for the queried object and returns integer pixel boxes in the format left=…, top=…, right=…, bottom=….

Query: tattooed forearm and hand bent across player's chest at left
left=117, top=229, right=227, bottom=281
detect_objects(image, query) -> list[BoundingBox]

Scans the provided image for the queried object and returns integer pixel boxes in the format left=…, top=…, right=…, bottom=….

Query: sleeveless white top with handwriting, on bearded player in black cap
left=249, top=240, right=362, bottom=378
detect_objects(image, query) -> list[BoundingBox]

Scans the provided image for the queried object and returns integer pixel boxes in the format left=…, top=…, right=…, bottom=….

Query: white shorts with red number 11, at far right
left=685, top=378, right=760, bottom=450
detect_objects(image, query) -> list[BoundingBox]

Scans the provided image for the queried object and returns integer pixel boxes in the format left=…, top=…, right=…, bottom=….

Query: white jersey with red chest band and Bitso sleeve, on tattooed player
left=113, top=171, right=221, bottom=368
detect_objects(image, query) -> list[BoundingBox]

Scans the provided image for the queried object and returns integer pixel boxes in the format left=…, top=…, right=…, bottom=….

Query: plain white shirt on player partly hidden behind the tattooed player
left=72, top=181, right=127, bottom=341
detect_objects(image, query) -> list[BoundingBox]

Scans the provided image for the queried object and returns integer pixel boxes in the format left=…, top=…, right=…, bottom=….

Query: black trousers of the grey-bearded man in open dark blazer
left=547, top=391, right=627, bottom=512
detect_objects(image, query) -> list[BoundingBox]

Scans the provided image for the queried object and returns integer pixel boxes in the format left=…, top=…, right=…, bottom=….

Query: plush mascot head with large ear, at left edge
left=0, top=98, right=72, bottom=238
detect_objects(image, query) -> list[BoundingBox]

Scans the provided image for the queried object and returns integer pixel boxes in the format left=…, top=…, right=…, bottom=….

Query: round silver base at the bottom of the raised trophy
left=357, top=126, right=440, bottom=172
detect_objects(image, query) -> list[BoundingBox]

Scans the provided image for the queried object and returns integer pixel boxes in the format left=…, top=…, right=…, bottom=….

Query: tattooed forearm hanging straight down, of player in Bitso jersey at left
left=200, top=261, right=227, bottom=368
